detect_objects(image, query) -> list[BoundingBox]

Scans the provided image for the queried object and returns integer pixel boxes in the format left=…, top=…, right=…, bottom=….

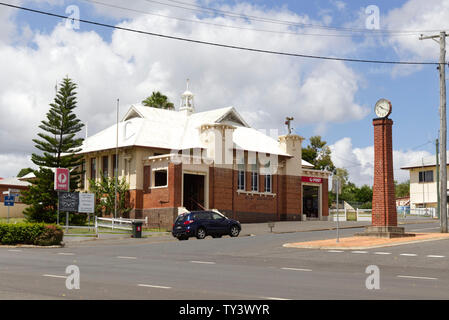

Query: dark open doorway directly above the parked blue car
left=183, top=173, right=205, bottom=211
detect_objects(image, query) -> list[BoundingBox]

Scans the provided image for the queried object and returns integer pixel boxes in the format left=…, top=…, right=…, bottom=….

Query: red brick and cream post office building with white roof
left=80, top=86, right=330, bottom=227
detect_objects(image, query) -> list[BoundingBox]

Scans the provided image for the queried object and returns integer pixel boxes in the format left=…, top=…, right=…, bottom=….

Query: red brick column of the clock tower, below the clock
left=372, top=119, right=397, bottom=226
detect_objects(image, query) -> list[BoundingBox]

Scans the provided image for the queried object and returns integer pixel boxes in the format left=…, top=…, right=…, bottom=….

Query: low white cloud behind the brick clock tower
left=329, top=137, right=431, bottom=186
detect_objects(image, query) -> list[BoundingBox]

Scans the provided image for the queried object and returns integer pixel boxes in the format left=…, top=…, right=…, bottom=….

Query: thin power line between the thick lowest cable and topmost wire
left=82, top=0, right=416, bottom=38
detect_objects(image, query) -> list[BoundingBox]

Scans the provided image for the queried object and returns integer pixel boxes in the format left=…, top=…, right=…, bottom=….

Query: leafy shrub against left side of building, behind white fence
left=89, top=175, right=131, bottom=217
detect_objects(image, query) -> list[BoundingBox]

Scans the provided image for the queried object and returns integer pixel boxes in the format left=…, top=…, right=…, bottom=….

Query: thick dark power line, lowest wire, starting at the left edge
left=0, top=2, right=439, bottom=65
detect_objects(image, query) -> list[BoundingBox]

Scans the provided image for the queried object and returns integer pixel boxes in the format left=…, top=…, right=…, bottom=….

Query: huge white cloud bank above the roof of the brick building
left=0, top=0, right=367, bottom=175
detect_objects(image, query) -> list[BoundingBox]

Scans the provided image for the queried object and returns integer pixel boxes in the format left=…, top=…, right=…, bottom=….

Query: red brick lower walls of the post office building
left=130, top=164, right=328, bottom=222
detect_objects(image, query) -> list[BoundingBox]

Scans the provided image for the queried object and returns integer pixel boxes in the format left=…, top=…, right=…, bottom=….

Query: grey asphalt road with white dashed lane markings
left=0, top=223, right=449, bottom=300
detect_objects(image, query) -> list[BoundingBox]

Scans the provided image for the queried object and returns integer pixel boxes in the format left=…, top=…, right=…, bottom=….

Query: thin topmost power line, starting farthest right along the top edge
left=144, top=0, right=448, bottom=35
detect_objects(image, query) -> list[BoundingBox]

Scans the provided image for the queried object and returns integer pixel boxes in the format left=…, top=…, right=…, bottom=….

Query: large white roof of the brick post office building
left=81, top=104, right=290, bottom=156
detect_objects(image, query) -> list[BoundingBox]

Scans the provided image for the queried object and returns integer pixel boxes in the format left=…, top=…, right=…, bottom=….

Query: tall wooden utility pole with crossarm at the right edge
left=419, top=31, right=447, bottom=233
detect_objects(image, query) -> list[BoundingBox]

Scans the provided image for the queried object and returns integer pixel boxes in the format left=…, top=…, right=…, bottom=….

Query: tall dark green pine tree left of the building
left=23, top=77, right=84, bottom=223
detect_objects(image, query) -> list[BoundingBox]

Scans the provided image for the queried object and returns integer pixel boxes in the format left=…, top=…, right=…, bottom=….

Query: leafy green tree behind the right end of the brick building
left=302, top=136, right=335, bottom=172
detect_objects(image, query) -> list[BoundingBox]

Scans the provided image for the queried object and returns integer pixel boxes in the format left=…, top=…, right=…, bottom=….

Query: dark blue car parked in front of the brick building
left=172, top=211, right=242, bottom=240
